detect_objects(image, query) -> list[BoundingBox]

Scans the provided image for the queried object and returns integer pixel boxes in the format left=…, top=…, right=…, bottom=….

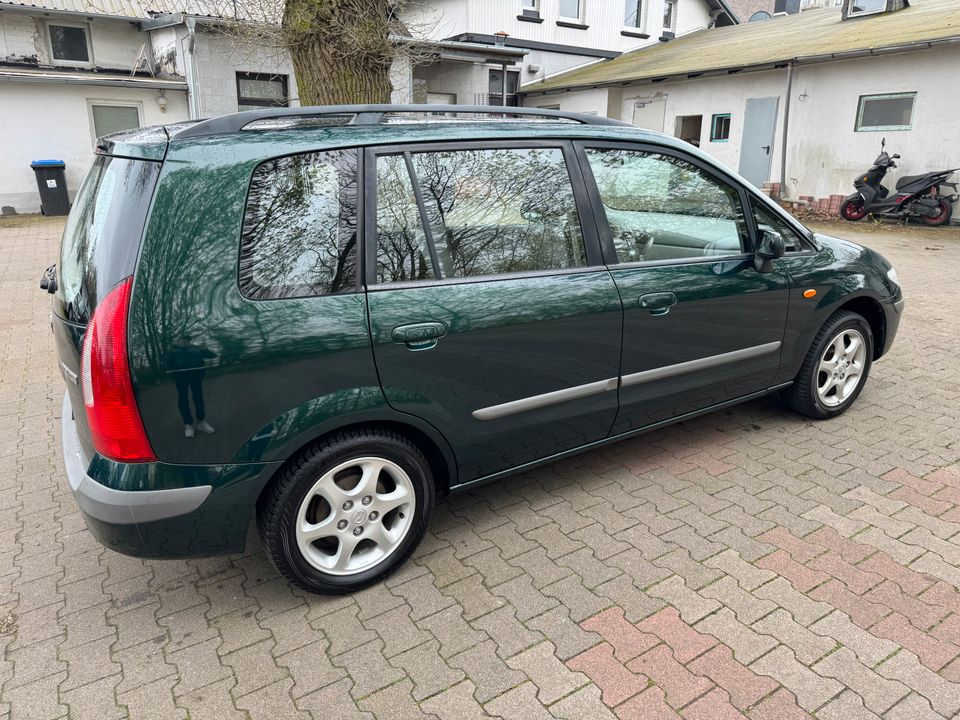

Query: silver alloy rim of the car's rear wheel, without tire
left=296, top=457, right=416, bottom=575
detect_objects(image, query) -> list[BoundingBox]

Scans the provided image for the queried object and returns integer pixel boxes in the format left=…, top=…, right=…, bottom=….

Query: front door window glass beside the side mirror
left=587, top=149, right=746, bottom=262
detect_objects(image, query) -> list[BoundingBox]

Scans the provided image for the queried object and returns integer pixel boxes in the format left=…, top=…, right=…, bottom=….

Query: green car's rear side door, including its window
left=365, top=142, right=622, bottom=481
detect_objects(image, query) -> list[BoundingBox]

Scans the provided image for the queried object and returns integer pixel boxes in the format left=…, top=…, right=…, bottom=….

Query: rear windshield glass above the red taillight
left=57, top=155, right=160, bottom=323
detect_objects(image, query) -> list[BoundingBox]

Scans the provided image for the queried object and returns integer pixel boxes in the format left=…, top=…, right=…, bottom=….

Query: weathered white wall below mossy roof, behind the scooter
left=524, top=46, right=960, bottom=216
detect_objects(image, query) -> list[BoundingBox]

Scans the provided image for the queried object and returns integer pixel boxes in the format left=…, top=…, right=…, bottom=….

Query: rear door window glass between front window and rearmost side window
left=377, top=148, right=587, bottom=278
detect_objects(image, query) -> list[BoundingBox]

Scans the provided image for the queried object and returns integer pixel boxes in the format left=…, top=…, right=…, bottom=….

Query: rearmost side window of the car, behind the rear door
left=239, top=149, right=357, bottom=300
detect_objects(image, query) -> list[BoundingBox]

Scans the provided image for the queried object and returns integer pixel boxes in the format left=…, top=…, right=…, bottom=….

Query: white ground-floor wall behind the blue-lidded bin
left=0, top=83, right=187, bottom=213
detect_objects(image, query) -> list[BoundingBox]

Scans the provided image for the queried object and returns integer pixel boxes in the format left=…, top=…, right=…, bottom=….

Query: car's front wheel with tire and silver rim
left=786, top=310, right=873, bottom=420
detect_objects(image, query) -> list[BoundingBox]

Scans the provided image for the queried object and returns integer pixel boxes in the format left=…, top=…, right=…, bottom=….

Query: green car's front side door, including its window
left=579, top=143, right=789, bottom=434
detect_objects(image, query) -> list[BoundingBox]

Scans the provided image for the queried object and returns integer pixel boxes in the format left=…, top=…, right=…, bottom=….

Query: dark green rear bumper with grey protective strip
left=61, top=397, right=280, bottom=558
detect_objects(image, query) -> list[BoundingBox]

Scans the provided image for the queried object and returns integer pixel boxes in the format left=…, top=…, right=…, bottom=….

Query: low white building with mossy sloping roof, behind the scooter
left=521, top=0, right=960, bottom=214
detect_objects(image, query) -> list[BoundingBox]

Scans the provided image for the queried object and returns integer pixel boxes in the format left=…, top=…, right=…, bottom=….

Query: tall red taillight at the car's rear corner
left=80, top=278, right=157, bottom=462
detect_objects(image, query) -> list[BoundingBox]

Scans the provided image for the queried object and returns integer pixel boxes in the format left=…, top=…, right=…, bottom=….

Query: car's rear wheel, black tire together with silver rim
left=257, top=429, right=435, bottom=595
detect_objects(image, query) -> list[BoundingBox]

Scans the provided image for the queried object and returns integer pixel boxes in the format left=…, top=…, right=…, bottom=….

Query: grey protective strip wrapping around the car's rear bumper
left=61, top=394, right=213, bottom=525
